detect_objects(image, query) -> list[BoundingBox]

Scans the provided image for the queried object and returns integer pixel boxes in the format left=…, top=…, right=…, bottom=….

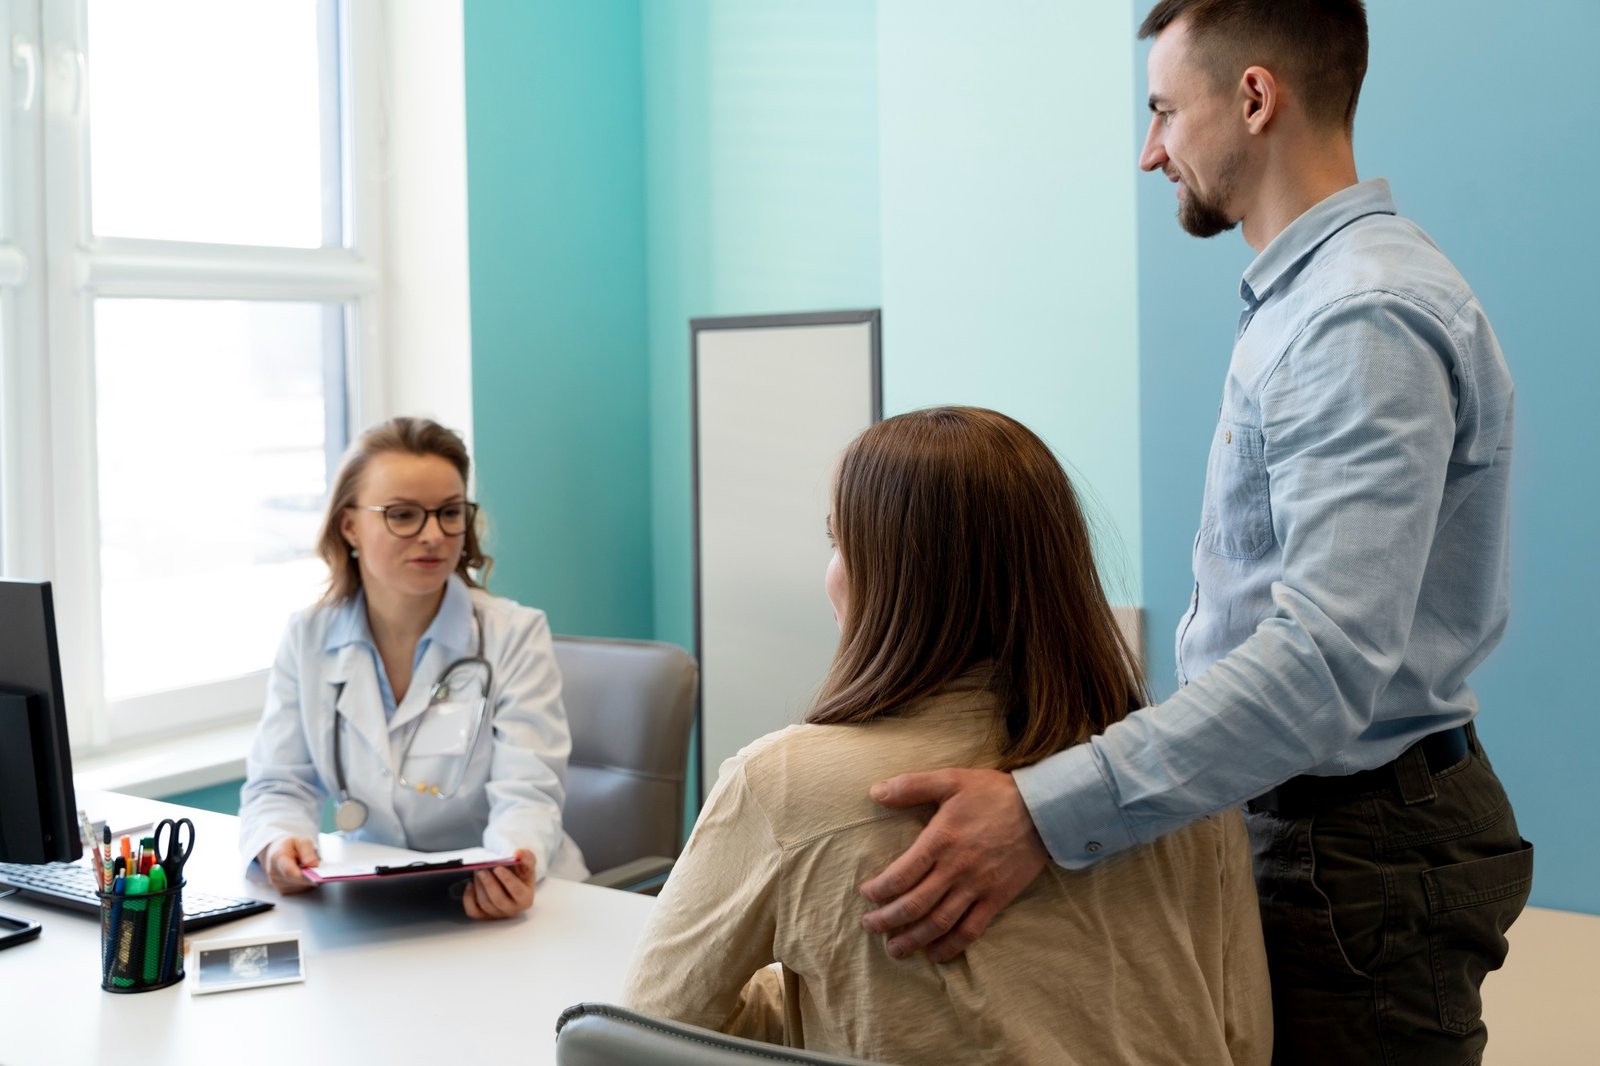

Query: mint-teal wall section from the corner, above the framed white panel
left=642, top=0, right=878, bottom=645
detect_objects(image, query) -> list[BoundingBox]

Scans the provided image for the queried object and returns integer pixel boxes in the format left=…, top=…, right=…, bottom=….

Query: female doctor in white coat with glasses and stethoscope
left=240, top=418, right=587, bottom=919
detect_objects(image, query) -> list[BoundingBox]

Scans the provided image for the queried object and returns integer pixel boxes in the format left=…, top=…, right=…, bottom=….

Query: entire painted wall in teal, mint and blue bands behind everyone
left=466, top=0, right=1600, bottom=912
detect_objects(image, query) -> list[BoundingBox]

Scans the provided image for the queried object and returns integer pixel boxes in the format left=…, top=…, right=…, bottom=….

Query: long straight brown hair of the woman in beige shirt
left=806, top=407, right=1146, bottom=770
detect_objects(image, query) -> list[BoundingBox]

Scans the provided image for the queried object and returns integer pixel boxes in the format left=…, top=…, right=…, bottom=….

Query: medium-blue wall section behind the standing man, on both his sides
left=1133, top=0, right=1600, bottom=912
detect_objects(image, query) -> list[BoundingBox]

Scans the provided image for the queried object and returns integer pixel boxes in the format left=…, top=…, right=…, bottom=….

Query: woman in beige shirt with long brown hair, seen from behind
left=624, top=408, right=1272, bottom=1066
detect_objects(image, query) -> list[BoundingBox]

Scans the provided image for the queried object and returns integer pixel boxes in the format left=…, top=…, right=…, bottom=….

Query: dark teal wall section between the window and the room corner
left=464, top=0, right=654, bottom=637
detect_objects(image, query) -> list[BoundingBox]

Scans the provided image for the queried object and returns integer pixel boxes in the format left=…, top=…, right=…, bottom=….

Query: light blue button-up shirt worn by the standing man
left=1016, top=179, right=1512, bottom=868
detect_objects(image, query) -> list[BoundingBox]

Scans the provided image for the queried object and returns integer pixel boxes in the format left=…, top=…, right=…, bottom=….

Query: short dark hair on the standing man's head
left=1139, top=0, right=1366, bottom=131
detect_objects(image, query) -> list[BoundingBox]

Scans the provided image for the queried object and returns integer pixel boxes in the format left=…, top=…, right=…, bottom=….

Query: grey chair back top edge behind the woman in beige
left=555, top=1004, right=870, bottom=1066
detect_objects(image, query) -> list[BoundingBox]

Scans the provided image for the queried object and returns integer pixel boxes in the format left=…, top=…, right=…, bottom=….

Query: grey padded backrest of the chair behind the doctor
left=555, top=637, right=699, bottom=893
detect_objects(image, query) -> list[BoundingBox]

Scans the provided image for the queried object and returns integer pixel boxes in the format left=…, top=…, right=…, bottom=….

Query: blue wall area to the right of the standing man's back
left=1357, top=0, right=1600, bottom=914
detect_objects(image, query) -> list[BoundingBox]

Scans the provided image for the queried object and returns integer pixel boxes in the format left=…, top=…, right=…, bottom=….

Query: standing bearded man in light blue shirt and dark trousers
left=862, top=0, right=1533, bottom=1066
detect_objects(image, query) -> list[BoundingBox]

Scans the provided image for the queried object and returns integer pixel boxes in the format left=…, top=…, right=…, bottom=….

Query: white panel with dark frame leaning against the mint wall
left=690, top=311, right=883, bottom=795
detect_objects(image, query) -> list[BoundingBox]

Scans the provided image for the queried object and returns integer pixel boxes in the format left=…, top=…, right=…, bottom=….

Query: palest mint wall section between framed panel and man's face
left=878, top=0, right=1141, bottom=603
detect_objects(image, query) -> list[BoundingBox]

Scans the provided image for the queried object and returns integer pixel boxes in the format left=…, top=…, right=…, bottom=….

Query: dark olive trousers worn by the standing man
left=1245, top=727, right=1533, bottom=1066
